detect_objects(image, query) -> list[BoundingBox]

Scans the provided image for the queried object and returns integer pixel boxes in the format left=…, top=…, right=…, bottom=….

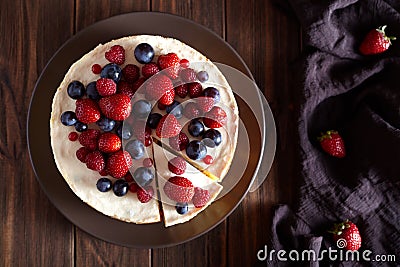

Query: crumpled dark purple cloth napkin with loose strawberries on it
left=269, top=0, right=400, bottom=266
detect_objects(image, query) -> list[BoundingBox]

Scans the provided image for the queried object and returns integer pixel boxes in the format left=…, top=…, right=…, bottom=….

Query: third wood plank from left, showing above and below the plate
left=152, top=0, right=226, bottom=266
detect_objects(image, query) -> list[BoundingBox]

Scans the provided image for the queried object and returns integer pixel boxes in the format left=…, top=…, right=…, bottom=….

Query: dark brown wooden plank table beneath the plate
left=0, top=0, right=301, bottom=266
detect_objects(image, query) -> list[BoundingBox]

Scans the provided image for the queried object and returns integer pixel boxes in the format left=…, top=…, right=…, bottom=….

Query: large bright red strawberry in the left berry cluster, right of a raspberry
left=99, top=93, right=132, bottom=121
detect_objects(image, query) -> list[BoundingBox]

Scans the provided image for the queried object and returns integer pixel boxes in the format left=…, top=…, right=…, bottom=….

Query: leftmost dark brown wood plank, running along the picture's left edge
left=0, top=0, right=74, bottom=266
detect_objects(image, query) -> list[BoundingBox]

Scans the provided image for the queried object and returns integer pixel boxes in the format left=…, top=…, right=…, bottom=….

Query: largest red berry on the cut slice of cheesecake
left=163, top=176, right=194, bottom=203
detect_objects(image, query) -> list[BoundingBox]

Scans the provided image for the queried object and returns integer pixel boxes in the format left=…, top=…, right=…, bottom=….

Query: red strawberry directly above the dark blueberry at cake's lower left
left=107, top=150, right=133, bottom=178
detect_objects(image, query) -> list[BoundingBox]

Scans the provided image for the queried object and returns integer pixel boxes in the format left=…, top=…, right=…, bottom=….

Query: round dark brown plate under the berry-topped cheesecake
left=27, top=12, right=272, bottom=248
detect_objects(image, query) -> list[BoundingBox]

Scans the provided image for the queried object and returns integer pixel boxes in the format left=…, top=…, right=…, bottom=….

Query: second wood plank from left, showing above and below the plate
left=75, top=0, right=151, bottom=266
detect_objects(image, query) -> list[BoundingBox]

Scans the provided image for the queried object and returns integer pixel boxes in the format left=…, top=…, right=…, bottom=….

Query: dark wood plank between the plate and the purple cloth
left=226, top=0, right=300, bottom=266
